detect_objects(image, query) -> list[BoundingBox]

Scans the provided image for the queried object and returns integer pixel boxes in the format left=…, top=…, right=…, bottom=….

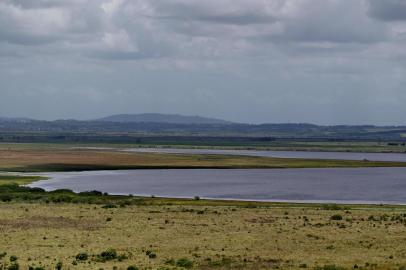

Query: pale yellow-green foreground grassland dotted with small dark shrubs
left=0, top=199, right=406, bottom=270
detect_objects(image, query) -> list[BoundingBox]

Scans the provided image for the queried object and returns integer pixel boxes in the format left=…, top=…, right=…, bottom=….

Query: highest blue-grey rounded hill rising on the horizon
left=95, top=113, right=232, bottom=125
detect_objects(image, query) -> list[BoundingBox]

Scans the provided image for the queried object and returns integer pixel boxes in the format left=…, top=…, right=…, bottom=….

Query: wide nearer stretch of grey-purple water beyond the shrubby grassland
left=31, top=168, right=406, bottom=204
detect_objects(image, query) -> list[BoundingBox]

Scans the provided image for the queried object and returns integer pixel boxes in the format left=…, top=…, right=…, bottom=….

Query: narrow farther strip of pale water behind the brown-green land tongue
left=123, top=148, right=406, bottom=162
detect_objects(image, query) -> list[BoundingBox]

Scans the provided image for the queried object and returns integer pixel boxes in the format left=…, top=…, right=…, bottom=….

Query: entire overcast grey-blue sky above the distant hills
left=0, top=0, right=406, bottom=125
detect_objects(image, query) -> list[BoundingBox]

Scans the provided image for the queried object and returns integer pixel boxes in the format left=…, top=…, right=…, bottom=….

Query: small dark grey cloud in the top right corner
left=368, top=0, right=406, bottom=21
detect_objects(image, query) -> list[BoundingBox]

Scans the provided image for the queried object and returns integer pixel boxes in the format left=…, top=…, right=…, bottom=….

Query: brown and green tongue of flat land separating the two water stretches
left=0, top=144, right=406, bottom=172
